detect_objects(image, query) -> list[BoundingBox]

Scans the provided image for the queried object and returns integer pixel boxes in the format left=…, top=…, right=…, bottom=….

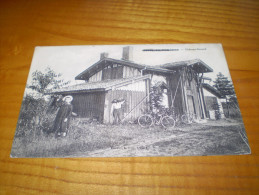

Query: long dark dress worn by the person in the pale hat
left=53, top=103, right=73, bottom=132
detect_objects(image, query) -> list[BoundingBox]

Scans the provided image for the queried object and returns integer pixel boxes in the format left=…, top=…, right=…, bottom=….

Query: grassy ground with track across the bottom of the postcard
left=11, top=119, right=250, bottom=157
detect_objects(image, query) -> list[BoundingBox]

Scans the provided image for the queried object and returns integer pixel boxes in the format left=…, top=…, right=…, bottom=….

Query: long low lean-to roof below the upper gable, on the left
left=46, top=75, right=151, bottom=94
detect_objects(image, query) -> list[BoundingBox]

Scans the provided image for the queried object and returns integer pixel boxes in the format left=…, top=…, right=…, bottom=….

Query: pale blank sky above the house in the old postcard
left=27, top=44, right=231, bottom=87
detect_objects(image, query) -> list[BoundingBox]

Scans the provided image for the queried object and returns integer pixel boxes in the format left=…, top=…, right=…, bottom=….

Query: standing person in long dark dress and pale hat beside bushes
left=53, top=96, right=73, bottom=137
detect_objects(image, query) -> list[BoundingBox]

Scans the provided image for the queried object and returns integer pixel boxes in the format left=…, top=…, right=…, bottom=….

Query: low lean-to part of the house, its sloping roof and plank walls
left=52, top=75, right=151, bottom=123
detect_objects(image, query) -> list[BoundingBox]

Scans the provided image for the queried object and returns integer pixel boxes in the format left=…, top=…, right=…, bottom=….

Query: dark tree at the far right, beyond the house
left=213, top=72, right=236, bottom=116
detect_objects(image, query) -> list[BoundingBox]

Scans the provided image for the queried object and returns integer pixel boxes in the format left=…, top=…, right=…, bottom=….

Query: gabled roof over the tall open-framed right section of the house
left=160, top=59, right=213, bottom=73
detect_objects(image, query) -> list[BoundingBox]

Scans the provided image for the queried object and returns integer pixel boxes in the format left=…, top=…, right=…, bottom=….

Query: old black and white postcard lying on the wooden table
left=11, top=44, right=251, bottom=158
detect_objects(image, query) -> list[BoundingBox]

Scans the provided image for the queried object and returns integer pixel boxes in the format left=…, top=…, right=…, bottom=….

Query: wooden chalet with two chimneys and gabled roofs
left=48, top=46, right=213, bottom=123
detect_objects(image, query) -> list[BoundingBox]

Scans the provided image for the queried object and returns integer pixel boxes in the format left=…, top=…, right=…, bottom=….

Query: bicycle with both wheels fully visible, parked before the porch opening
left=138, top=114, right=175, bottom=128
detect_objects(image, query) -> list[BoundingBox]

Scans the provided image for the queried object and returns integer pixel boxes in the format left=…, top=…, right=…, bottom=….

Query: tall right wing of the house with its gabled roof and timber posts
left=161, top=59, right=213, bottom=119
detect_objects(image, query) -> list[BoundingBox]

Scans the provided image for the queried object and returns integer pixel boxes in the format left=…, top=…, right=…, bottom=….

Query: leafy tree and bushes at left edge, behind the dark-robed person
left=16, top=68, right=69, bottom=136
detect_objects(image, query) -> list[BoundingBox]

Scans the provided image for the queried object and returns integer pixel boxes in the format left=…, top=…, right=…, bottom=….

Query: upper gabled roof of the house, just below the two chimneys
left=75, top=58, right=174, bottom=80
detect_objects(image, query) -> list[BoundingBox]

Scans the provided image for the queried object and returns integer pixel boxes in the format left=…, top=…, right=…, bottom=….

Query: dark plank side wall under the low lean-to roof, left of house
left=72, top=92, right=105, bottom=122
